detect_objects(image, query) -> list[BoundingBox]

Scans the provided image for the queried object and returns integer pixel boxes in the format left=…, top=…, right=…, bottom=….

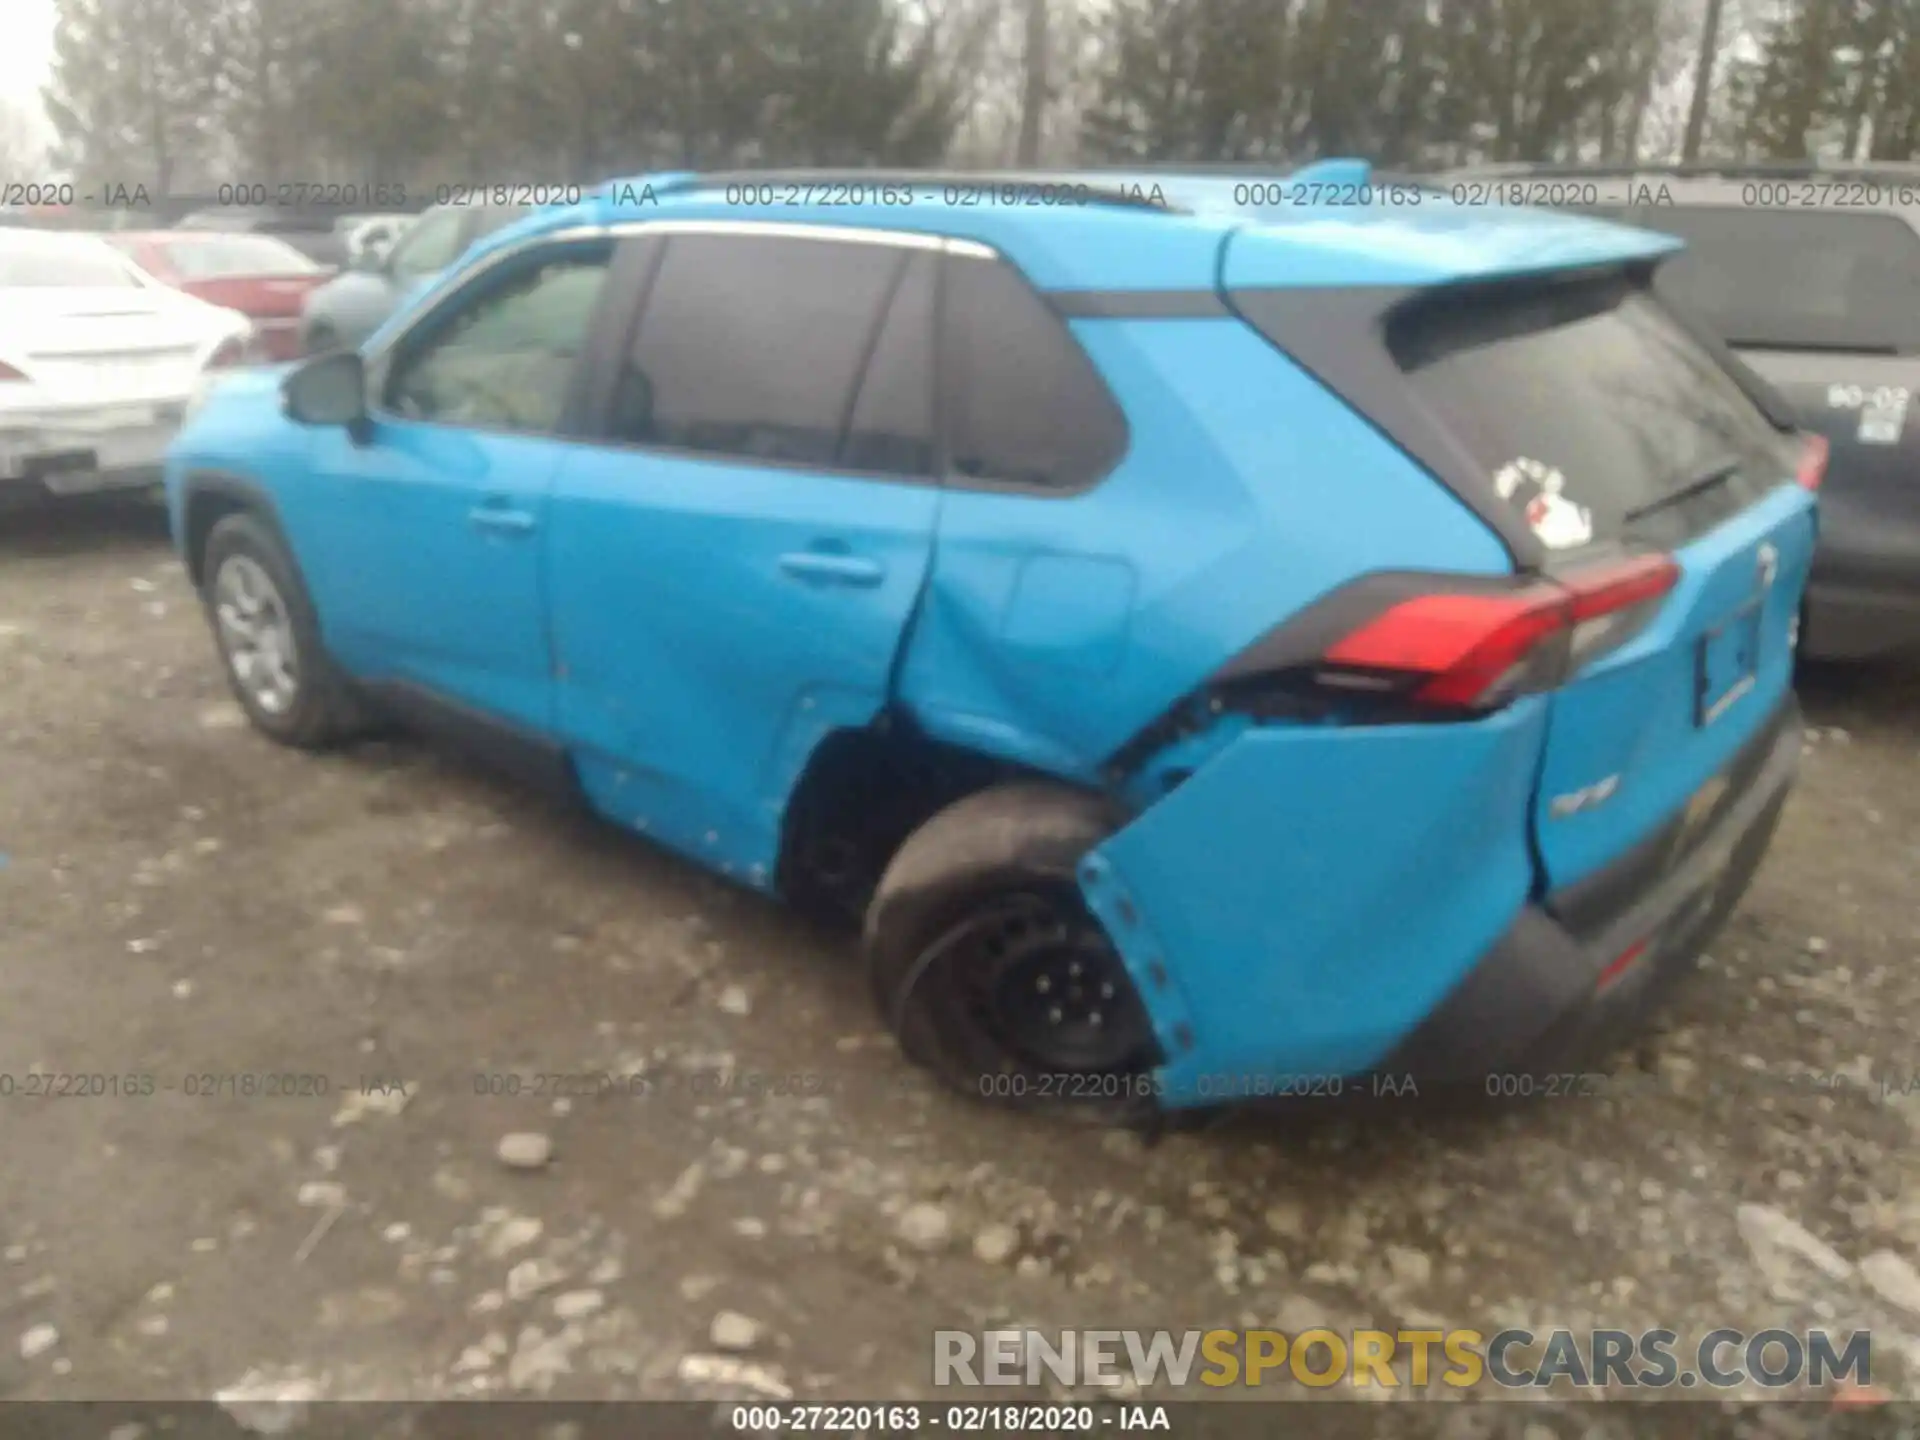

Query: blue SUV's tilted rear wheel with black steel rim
left=866, top=781, right=1158, bottom=1123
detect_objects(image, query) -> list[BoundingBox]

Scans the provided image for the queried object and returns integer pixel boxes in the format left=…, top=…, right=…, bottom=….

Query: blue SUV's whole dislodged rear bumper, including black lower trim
left=1081, top=697, right=1801, bottom=1108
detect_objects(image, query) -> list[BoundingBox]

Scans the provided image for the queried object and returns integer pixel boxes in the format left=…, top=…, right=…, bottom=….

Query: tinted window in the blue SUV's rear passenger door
left=611, top=234, right=922, bottom=467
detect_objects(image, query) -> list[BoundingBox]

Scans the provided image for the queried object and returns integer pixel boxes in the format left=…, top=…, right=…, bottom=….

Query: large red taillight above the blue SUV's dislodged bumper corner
left=1325, top=555, right=1680, bottom=708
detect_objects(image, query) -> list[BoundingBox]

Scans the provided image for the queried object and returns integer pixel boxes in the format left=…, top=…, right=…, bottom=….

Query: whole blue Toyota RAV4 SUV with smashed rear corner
left=167, top=161, right=1822, bottom=1112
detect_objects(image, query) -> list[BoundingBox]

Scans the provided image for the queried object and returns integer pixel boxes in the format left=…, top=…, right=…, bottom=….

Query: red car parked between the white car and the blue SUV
left=102, top=230, right=334, bottom=361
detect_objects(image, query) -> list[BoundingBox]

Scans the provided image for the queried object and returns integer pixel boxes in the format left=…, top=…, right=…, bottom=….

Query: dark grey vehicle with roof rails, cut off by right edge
left=1452, top=163, right=1920, bottom=659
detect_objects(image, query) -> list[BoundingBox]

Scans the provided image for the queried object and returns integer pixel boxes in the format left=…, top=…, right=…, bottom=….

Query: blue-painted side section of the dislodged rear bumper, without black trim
left=1081, top=697, right=1548, bottom=1106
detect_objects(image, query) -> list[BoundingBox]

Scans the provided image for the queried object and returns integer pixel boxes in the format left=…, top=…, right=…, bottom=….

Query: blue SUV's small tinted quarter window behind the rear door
left=945, top=255, right=1127, bottom=492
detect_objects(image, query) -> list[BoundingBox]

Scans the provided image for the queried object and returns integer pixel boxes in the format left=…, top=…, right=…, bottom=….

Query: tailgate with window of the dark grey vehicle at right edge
left=1634, top=210, right=1920, bottom=622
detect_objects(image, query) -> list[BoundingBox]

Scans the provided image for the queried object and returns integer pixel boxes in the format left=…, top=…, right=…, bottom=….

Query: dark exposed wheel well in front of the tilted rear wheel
left=776, top=714, right=1090, bottom=924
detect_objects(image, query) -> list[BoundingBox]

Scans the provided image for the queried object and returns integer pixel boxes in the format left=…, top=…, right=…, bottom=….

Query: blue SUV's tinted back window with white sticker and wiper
left=1388, top=280, right=1789, bottom=549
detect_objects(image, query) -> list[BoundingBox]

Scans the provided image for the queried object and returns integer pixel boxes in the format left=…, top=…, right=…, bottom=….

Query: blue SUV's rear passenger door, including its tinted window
left=549, top=227, right=941, bottom=887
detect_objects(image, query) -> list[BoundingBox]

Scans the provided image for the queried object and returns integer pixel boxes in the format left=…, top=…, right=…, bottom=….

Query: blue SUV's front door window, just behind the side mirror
left=386, top=246, right=609, bottom=434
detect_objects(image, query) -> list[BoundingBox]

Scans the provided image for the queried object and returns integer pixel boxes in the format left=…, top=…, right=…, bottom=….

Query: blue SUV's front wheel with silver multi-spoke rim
left=200, top=513, right=365, bottom=751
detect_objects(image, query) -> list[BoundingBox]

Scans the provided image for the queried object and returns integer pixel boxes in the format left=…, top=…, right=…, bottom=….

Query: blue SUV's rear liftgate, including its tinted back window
left=1392, top=278, right=1814, bottom=889
